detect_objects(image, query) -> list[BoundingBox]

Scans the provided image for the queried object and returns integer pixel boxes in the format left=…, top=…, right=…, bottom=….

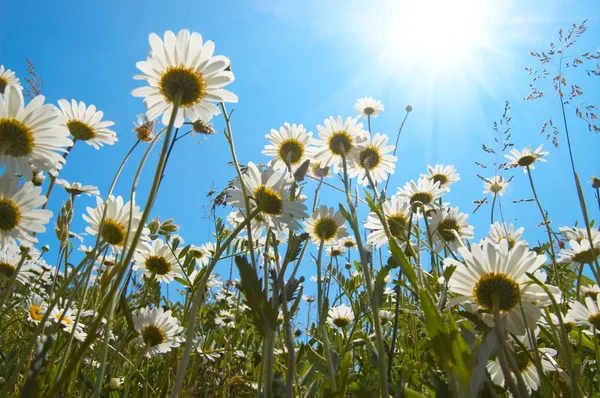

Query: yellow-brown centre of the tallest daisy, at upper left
left=158, top=65, right=206, bottom=108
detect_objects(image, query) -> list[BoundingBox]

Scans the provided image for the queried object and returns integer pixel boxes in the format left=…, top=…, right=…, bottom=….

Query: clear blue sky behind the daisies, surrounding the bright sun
left=0, top=0, right=600, bottom=286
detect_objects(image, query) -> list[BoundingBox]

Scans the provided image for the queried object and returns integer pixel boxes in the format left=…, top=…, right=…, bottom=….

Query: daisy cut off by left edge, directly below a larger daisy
left=0, top=173, right=52, bottom=248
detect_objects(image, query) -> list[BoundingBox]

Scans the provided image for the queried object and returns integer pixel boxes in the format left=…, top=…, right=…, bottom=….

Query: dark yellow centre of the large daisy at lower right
left=473, top=272, right=520, bottom=312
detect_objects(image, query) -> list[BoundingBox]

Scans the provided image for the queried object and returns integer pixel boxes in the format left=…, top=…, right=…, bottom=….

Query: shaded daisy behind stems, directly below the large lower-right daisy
left=487, top=333, right=558, bottom=393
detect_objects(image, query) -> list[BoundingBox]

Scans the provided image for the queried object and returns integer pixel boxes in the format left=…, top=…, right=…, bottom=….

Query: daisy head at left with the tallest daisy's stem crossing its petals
left=83, top=195, right=150, bottom=253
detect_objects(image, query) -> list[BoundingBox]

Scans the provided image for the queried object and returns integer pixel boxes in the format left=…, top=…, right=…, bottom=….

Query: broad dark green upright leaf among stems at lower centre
left=235, top=256, right=277, bottom=336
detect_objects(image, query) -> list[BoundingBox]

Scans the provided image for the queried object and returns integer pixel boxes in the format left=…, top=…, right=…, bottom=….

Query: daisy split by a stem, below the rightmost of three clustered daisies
left=364, top=195, right=411, bottom=249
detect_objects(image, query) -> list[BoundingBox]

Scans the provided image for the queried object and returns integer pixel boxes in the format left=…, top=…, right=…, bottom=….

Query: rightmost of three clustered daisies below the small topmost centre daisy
left=348, top=133, right=397, bottom=185
